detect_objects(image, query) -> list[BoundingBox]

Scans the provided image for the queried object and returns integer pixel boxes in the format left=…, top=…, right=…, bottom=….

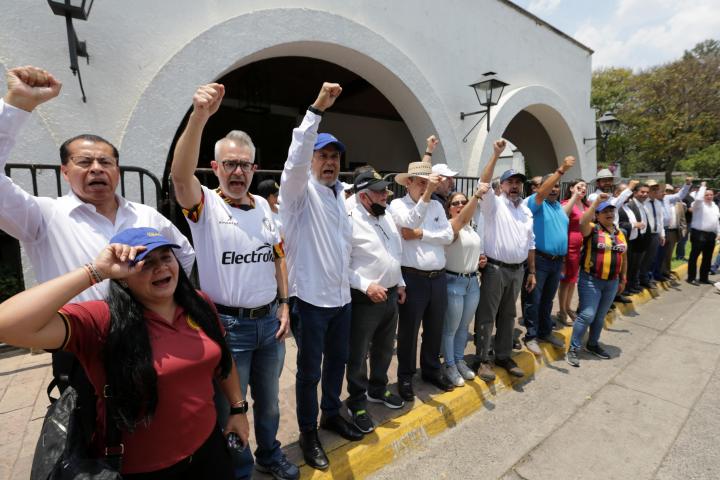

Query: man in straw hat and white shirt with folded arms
left=390, top=162, right=454, bottom=401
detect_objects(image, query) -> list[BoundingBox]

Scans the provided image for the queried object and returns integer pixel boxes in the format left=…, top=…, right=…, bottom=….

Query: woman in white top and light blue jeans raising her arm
left=442, top=183, right=490, bottom=387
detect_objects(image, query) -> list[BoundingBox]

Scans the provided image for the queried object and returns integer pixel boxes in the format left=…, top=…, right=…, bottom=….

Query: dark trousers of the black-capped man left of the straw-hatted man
left=347, top=287, right=398, bottom=410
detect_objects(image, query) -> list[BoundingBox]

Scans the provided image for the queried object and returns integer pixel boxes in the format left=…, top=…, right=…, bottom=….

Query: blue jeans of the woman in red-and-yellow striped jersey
left=570, top=270, right=619, bottom=349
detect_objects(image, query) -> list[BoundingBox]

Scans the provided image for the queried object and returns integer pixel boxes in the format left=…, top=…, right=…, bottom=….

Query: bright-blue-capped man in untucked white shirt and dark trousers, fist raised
left=280, top=83, right=363, bottom=470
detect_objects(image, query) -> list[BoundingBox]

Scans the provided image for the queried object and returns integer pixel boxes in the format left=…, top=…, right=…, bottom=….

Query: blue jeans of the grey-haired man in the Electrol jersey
left=218, top=304, right=285, bottom=478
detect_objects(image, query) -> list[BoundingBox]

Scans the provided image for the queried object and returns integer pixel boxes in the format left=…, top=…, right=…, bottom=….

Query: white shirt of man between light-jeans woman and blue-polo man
left=480, top=193, right=535, bottom=263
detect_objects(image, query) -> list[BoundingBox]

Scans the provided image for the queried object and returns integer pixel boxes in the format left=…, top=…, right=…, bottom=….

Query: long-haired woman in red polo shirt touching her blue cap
left=0, top=228, right=248, bottom=479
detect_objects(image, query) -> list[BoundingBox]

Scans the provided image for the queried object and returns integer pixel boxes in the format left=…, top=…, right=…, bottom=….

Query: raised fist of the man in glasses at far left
left=5, top=65, right=62, bottom=112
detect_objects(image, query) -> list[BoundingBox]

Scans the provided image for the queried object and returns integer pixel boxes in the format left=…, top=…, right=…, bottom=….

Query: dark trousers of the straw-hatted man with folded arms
left=397, top=270, right=447, bottom=380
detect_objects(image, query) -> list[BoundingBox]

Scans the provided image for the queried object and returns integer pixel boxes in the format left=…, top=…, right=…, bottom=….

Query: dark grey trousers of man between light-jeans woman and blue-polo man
left=475, top=263, right=524, bottom=362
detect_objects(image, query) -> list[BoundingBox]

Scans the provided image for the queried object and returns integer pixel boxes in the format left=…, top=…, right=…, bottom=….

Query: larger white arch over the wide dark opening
left=121, top=8, right=460, bottom=178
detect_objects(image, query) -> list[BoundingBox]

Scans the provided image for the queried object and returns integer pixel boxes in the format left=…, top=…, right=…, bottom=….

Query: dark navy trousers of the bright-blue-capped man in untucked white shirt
left=291, top=297, right=352, bottom=432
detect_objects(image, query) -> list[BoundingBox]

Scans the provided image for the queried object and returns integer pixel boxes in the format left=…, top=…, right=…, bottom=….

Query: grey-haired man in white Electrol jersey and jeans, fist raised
left=170, top=83, right=300, bottom=479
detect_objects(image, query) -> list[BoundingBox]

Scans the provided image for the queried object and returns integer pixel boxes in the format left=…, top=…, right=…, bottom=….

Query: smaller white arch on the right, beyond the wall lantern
left=468, top=85, right=595, bottom=178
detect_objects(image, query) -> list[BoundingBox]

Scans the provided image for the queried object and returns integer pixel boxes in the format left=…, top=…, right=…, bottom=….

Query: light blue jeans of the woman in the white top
left=442, top=273, right=480, bottom=365
